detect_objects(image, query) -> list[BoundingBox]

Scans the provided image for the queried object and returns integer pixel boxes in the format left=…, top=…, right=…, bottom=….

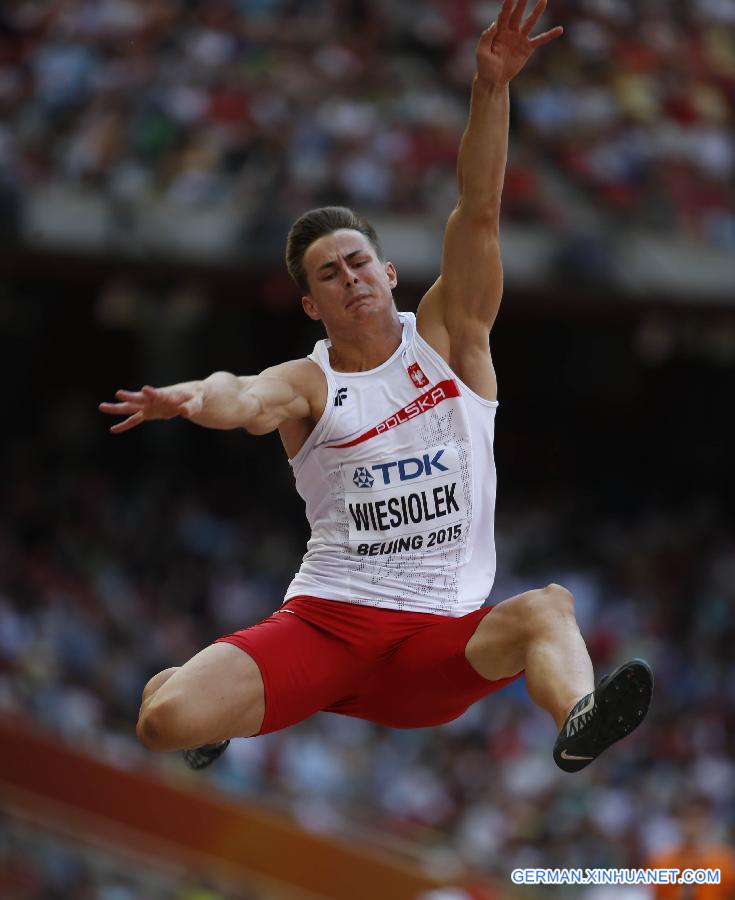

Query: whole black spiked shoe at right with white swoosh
left=554, top=659, right=653, bottom=772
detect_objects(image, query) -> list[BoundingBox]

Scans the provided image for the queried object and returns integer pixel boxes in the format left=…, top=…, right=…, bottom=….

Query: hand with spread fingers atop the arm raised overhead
left=476, top=0, right=564, bottom=85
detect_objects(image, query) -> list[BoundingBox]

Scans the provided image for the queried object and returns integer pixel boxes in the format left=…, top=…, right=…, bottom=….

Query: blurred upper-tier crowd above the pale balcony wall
left=0, top=0, right=735, bottom=248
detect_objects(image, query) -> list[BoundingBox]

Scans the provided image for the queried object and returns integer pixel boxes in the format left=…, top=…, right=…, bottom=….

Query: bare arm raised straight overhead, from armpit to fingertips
left=417, top=0, right=562, bottom=399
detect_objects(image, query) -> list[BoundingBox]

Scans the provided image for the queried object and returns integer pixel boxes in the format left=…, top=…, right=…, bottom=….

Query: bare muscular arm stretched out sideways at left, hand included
left=99, top=359, right=326, bottom=434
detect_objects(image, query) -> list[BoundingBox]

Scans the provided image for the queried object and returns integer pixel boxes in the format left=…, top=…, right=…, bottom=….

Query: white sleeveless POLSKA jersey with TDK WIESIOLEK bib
left=286, top=313, right=498, bottom=616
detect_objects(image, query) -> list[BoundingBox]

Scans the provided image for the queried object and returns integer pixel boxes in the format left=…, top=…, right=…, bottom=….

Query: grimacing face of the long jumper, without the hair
left=301, top=228, right=398, bottom=330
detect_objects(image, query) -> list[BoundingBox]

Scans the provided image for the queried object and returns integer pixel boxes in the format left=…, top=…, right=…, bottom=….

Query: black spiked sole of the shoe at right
left=554, top=659, right=653, bottom=772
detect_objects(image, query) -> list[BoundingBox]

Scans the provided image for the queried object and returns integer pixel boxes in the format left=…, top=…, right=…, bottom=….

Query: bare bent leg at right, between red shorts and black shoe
left=465, top=584, right=595, bottom=728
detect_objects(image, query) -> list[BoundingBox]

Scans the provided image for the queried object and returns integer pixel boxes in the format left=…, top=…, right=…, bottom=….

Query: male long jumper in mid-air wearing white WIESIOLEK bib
left=100, top=0, right=653, bottom=772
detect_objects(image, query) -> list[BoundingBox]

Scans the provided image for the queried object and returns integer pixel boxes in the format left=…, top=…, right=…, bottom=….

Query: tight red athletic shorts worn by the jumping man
left=215, top=597, right=522, bottom=734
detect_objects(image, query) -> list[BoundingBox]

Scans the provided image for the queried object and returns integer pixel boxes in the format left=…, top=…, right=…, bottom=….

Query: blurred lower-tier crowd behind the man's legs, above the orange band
left=0, top=454, right=735, bottom=882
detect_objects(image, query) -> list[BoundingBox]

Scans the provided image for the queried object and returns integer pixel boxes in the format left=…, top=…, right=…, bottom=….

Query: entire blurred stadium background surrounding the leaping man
left=0, top=0, right=735, bottom=900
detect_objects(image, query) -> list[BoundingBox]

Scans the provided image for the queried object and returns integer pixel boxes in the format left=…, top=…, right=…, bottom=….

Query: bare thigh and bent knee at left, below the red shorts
left=137, top=643, right=265, bottom=751
